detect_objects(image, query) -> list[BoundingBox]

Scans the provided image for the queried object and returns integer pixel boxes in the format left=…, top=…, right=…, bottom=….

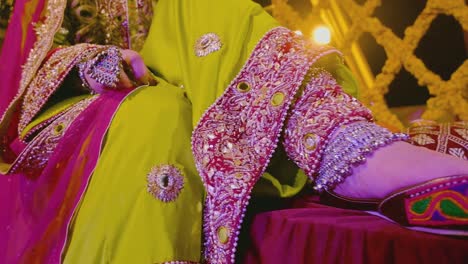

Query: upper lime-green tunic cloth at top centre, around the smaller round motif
left=140, top=0, right=278, bottom=126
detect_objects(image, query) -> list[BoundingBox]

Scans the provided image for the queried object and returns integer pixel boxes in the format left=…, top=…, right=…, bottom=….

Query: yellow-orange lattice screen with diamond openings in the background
left=266, top=0, right=468, bottom=129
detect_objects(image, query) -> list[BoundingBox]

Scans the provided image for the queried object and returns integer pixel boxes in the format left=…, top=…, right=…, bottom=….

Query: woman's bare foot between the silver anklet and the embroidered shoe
left=333, top=142, right=468, bottom=199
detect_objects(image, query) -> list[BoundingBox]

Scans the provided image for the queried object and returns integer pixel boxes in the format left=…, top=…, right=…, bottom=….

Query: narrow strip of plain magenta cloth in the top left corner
left=0, top=0, right=46, bottom=117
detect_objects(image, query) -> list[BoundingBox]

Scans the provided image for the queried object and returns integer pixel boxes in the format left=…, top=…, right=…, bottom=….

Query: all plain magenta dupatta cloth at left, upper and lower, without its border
left=0, top=0, right=135, bottom=264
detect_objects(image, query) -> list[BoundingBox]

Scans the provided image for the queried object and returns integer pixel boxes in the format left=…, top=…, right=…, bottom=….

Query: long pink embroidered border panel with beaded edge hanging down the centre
left=192, top=28, right=337, bottom=263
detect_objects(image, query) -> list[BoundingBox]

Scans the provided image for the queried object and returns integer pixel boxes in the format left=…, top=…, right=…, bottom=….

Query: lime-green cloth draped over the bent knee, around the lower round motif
left=64, top=80, right=204, bottom=264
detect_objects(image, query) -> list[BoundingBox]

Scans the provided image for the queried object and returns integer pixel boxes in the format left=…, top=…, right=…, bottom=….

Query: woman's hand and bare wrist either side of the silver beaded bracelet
left=84, top=50, right=156, bottom=93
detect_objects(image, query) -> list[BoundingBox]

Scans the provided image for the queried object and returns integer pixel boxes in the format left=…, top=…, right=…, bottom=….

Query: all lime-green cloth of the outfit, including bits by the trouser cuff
left=59, top=0, right=366, bottom=263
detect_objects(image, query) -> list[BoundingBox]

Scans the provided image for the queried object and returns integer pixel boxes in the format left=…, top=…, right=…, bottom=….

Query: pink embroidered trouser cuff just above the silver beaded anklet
left=284, top=69, right=372, bottom=191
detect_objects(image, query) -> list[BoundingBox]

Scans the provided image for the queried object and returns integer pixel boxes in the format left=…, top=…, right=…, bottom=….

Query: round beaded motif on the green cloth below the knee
left=147, top=164, right=184, bottom=203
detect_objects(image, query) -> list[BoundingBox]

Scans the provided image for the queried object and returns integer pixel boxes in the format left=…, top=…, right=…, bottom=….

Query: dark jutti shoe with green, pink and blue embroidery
left=320, top=175, right=468, bottom=236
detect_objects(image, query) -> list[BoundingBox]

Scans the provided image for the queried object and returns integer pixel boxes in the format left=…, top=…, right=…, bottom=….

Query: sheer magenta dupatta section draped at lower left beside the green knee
left=0, top=91, right=128, bottom=263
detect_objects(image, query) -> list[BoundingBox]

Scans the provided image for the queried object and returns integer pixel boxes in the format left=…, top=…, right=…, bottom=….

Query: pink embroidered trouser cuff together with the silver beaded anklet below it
left=283, top=68, right=407, bottom=192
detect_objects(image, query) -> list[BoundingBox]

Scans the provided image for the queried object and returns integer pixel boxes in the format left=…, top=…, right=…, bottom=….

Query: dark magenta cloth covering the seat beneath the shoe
left=243, top=196, right=468, bottom=264
